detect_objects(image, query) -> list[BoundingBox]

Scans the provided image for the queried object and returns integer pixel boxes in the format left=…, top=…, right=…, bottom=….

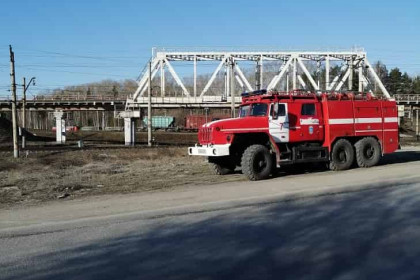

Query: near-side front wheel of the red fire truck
left=241, top=145, right=273, bottom=181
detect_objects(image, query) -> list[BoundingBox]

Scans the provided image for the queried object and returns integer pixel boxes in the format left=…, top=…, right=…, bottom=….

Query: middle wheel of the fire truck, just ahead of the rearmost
left=330, top=139, right=354, bottom=170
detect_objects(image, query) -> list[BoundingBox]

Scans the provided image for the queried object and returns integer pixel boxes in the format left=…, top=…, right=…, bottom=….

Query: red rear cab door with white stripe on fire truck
left=299, top=102, right=324, bottom=141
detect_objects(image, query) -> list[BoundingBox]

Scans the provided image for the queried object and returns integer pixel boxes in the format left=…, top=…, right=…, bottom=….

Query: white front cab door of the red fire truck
left=268, top=102, right=289, bottom=143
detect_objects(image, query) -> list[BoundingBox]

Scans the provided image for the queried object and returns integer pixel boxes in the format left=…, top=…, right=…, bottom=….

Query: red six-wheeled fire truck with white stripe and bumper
left=188, top=90, right=399, bottom=180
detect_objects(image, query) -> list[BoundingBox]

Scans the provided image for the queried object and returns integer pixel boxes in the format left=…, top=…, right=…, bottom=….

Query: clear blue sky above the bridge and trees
left=0, top=0, right=420, bottom=96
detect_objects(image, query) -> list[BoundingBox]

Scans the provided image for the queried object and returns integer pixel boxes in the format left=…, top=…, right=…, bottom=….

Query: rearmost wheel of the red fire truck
left=354, top=137, right=382, bottom=167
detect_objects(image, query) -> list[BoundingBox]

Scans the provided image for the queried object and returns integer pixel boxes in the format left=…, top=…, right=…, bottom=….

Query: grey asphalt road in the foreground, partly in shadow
left=0, top=149, right=420, bottom=279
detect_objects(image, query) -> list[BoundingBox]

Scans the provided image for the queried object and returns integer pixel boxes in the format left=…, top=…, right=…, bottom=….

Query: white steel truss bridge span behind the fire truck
left=127, top=50, right=391, bottom=109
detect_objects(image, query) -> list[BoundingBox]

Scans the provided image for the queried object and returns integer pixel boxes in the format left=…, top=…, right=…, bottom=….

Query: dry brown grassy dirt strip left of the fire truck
left=0, top=147, right=244, bottom=208
